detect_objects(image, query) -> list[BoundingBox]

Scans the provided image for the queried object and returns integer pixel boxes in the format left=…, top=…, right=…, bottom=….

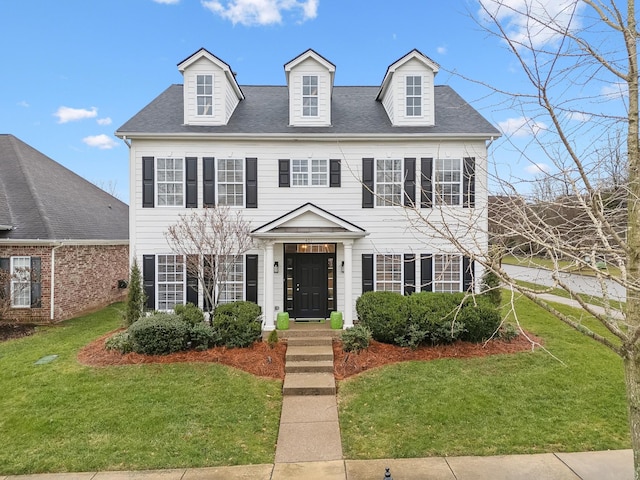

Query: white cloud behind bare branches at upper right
left=479, top=0, right=583, bottom=48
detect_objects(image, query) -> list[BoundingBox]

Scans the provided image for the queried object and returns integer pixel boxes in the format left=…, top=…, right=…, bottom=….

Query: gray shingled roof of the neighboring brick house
left=0, top=134, right=129, bottom=240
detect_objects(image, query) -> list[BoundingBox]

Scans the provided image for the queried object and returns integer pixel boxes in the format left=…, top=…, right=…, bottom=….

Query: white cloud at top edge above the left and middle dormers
left=201, top=0, right=319, bottom=26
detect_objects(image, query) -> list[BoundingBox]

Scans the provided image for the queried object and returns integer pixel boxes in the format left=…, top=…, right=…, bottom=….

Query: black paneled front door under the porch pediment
left=293, top=253, right=327, bottom=318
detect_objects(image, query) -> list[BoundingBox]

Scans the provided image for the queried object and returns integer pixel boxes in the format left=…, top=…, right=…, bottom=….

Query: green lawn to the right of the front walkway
left=339, top=299, right=630, bottom=459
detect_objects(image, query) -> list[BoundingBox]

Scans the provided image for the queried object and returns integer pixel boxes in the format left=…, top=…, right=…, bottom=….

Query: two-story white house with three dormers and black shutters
left=116, top=49, right=499, bottom=330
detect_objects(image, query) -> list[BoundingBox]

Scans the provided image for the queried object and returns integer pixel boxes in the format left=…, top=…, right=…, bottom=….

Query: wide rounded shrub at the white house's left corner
left=128, top=313, right=189, bottom=355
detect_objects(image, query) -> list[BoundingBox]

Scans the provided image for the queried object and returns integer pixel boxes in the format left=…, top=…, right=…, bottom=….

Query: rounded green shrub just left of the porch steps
left=213, top=301, right=262, bottom=348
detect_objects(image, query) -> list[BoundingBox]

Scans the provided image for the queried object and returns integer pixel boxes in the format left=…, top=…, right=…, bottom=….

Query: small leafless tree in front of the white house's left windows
left=165, top=205, right=253, bottom=311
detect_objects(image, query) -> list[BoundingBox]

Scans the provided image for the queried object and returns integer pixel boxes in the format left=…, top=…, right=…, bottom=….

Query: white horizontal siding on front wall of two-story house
left=129, top=139, right=487, bottom=318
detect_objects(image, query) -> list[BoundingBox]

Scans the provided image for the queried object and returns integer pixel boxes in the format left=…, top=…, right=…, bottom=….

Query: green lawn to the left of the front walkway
left=0, top=305, right=282, bottom=474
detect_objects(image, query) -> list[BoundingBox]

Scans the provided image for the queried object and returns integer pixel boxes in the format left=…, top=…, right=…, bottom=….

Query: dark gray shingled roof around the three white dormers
left=116, top=85, right=500, bottom=137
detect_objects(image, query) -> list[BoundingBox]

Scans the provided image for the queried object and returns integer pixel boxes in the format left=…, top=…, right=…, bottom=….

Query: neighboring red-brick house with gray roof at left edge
left=0, top=135, right=129, bottom=323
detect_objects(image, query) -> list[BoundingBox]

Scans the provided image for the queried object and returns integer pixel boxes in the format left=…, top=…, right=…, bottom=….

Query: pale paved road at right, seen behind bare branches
left=502, top=265, right=626, bottom=301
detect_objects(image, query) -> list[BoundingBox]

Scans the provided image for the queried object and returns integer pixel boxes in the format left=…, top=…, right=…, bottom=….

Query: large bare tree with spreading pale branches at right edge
left=411, top=0, right=640, bottom=472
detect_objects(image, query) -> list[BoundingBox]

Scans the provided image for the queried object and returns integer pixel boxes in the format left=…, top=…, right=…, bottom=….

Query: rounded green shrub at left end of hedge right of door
left=356, top=292, right=409, bottom=343
